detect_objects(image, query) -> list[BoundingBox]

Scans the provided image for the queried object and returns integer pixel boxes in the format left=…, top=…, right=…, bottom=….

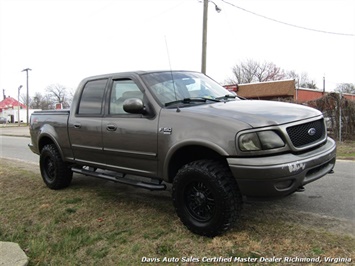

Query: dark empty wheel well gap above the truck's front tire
left=168, top=146, right=226, bottom=182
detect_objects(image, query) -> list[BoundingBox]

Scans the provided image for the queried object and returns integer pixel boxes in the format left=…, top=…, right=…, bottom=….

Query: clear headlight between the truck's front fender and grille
left=239, top=131, right=285, bottom=151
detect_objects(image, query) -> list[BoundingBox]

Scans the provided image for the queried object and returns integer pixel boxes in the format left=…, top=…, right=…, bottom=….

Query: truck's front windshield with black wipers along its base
left=142, top=71, right=236, bottom=106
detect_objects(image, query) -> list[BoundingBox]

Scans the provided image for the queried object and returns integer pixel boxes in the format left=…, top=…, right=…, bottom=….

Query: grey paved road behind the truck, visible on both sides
left=0, top=135, right=355, bottom=221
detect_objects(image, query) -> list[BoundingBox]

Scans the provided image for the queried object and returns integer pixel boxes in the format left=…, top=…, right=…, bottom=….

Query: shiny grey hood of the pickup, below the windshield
left=188, top=100, right=322, bottom=127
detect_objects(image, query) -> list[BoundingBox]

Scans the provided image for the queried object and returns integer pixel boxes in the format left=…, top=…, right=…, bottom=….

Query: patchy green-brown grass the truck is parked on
left=0, top=159, right=355, bottom=265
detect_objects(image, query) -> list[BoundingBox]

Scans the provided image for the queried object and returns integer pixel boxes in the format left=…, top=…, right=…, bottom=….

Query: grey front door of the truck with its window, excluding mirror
left=102, top=79, right=158, bottom=177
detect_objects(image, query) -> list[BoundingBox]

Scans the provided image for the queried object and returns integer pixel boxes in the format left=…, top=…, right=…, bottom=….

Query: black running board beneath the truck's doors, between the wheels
left=71, top=167, right=166, bottom=190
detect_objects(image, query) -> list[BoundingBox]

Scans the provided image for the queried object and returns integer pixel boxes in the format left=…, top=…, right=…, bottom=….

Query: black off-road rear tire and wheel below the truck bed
left=39, top=144, right=73, bottom=189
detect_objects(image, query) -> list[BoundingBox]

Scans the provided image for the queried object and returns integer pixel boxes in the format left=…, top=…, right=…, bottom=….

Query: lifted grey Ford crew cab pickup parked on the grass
left=29, top=71, right=336, bottom=237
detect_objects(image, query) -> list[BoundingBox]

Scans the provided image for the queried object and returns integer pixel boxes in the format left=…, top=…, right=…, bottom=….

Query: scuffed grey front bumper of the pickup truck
left=227, top=138, right=336, bottom=197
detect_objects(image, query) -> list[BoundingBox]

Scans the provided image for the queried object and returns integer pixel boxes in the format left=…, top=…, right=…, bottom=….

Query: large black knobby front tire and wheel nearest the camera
left=172, top=160, right=242, bottom=237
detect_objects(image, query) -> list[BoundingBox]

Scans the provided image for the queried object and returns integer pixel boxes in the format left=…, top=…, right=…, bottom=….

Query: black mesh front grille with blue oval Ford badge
left=286, top=119, right=325, bottom=148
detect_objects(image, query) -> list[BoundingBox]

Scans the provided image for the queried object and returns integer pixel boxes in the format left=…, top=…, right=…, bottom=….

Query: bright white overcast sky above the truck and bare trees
left=0, top=0, right=355, bottom=99
